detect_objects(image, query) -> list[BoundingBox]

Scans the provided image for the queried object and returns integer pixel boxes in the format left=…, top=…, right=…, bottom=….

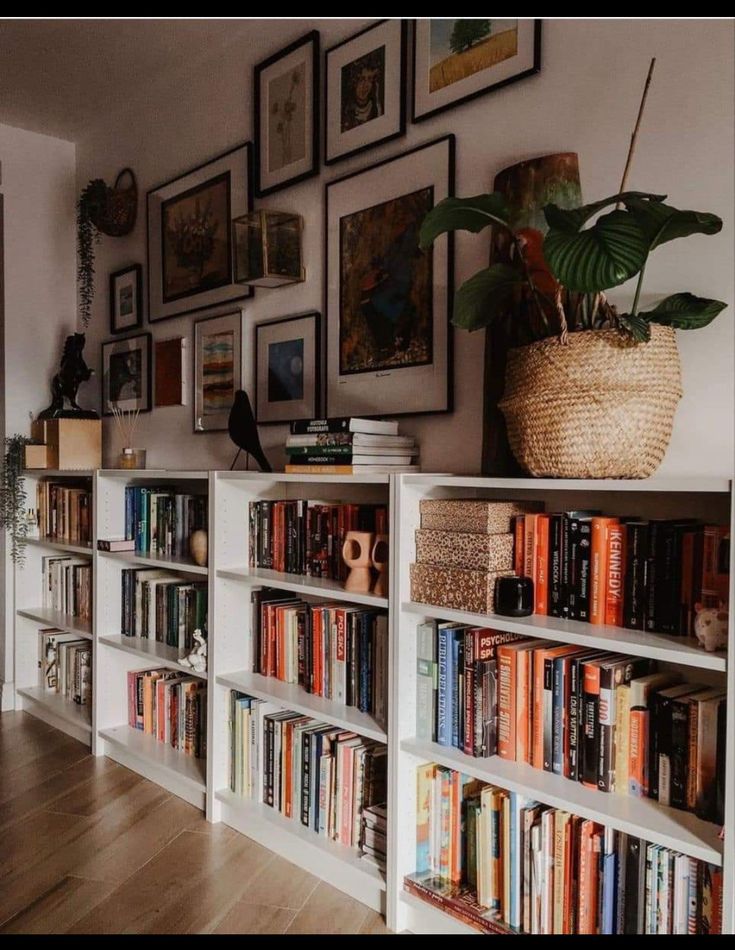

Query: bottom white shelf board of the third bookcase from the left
left=216, top=789, right=386, bottom=911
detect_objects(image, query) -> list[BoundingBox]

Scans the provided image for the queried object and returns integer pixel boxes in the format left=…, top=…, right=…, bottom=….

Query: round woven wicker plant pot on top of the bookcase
left=499, top=325, right=682, bottom=478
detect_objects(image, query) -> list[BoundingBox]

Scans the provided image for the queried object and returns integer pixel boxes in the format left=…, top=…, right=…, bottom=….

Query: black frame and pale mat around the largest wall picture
left=324, top=134, right=456, bottom=418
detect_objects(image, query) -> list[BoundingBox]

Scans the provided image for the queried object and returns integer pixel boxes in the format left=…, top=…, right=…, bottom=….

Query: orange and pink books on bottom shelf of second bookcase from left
left=127, top=669, right=207, bottom=759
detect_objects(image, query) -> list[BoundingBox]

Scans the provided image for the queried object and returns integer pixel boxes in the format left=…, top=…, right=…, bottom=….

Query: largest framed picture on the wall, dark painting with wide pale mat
left=326, top=135, right=454, bottom=416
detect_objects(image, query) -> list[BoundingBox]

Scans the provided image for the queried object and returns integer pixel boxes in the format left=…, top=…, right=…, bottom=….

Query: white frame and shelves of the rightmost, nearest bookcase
left=387, top=474, right=735, bottom=935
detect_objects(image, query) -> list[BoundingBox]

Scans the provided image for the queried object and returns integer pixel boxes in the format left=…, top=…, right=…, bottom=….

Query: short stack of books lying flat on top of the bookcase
left=286, top=417, right=419, bottom=475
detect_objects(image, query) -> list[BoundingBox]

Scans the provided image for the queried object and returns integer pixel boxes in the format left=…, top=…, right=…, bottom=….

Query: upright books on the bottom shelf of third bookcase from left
left=230, top=690, right=387, bottom=848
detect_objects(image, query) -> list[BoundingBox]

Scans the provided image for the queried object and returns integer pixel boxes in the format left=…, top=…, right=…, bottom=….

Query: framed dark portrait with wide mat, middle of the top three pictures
left=324, top=20, right=407, bottom=165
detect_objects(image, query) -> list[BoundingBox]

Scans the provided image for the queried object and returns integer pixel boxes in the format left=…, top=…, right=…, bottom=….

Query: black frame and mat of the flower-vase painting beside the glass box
left=146, top=142, right=253, bottom=324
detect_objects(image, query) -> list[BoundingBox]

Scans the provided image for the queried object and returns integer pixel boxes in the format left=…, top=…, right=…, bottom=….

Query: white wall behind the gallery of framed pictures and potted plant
left=78, top=20, right=735, bottom=484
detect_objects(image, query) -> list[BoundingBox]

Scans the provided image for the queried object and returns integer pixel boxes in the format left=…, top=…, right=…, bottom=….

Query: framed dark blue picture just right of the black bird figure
left=255, top=313, right=321, bottom=425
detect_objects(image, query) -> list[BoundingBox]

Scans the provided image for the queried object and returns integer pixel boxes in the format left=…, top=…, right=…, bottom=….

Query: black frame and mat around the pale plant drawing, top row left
left=253, top=30, right=321, bottom=198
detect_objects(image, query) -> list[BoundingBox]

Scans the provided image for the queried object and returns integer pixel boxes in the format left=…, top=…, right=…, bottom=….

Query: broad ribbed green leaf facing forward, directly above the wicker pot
left=544, top=211, right=648, bottom=293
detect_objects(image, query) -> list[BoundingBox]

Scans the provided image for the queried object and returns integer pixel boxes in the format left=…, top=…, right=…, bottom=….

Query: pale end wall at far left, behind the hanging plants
left=0, top=125, right=76, bottom=708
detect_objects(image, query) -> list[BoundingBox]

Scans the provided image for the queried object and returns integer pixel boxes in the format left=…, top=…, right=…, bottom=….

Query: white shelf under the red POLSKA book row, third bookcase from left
left=217, top=670, right=388, bottom=742
